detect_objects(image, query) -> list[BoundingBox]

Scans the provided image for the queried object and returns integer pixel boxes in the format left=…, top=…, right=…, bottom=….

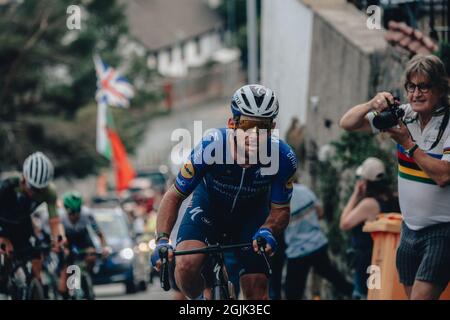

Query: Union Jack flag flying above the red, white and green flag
left=94, top=56, right=134, bottom=108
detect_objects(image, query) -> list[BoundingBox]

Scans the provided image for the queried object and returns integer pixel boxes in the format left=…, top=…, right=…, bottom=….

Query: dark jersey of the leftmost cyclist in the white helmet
left=0, top=177, right=58, bottom=224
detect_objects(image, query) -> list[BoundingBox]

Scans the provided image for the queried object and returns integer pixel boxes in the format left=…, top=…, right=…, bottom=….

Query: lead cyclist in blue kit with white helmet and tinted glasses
left=152, top=85, right=297, bottom=299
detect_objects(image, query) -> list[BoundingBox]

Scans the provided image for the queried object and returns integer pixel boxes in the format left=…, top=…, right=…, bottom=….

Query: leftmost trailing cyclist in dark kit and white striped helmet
left=0, top=152, right=63, bottom=298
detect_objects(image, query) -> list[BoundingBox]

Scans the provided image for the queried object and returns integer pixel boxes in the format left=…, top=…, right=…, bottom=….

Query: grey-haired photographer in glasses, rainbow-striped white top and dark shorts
left=340, top=55, right=450, bottom=299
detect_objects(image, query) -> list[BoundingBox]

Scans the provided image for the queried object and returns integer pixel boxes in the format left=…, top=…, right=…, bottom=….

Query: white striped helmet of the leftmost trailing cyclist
left=23, top=152, right=53, bottom=189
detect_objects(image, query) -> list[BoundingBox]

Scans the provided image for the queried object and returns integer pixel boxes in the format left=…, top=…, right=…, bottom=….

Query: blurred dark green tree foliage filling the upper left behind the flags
left=0, top=0, right=161, bottom=176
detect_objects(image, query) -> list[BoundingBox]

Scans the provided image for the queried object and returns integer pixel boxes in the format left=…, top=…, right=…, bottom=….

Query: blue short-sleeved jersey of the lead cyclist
left=175, top=128, right=297, bottom=213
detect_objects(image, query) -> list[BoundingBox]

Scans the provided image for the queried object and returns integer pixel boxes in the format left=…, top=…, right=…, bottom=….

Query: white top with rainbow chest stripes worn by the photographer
left=367, top=104, right=450, bottom=230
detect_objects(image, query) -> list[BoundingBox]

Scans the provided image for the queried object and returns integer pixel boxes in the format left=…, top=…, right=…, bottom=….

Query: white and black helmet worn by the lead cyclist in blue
left=231, top=84, right=279, bottom=119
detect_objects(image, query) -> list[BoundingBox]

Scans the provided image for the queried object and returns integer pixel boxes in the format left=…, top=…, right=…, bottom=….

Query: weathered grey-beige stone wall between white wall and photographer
left=302, top=2, right=387, bottom=188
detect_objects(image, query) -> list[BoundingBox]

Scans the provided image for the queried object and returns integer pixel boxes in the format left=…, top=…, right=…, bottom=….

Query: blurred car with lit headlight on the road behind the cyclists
left=92, top=206, right=150, bottom=293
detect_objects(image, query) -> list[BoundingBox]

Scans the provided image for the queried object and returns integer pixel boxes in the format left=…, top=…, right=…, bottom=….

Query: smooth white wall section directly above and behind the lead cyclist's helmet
left=261, top=0, right=312, bottom=138
